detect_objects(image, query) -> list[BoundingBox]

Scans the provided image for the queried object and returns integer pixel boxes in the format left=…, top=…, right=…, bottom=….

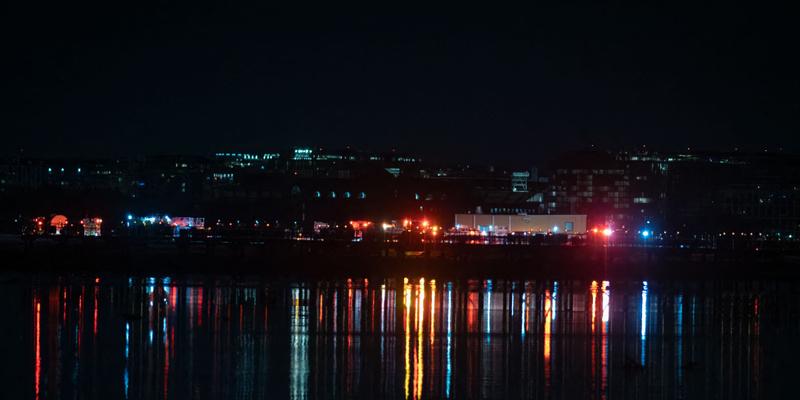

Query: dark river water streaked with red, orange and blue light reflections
left=0, top=276, right=800, bottom=399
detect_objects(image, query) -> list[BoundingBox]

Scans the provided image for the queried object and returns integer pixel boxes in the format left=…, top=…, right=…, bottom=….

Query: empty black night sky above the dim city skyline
left=0, top=2, right=800, bottom=162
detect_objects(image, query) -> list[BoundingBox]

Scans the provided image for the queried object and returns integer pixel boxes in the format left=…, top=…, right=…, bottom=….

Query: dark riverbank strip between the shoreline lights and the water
left=0, top=236, right=800, bottom=279
